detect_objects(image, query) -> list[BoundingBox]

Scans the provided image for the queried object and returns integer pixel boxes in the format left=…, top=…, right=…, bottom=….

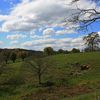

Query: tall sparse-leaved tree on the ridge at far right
left=83, top=32, right=100, bottom=51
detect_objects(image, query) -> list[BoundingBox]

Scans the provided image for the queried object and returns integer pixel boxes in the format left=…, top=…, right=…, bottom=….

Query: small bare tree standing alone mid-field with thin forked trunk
left=27, top=58, right=49, bottom=84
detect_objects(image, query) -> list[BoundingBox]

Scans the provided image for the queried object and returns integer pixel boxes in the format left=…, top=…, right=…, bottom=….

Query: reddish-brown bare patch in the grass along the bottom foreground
left=22, top=85, right=94, bottom=100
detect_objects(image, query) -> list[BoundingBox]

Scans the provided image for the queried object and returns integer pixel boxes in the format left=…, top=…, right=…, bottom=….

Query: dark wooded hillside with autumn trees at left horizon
left=0, top=48, right=43, bottom=64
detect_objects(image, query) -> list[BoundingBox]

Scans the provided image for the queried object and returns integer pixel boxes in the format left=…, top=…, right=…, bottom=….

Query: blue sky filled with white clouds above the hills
left=0, top=0, right=100, bottom=50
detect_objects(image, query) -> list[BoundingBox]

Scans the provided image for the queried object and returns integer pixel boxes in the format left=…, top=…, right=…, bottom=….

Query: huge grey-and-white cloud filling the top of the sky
left=0, top=0, right=95, bottom=31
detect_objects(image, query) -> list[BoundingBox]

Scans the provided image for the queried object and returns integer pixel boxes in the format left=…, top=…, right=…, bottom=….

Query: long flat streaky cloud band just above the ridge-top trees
left=21, top=37, right=84, bottom=50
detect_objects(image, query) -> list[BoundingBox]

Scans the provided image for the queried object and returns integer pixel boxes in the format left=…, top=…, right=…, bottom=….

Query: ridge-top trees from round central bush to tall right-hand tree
left=44, top=32, right=100, bottom=56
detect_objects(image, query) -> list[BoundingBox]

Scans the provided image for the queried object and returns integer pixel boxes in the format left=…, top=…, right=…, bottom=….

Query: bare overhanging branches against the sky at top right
left=66, top=0, right=100, bottom=29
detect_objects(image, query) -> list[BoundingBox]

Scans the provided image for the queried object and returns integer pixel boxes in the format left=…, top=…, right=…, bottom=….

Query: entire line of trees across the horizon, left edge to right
left=0, top=32, right=100, bottom=64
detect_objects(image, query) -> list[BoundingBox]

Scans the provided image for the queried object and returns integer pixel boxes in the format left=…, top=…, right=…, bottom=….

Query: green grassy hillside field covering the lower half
left=0, top=52, right=100, bottom=100
